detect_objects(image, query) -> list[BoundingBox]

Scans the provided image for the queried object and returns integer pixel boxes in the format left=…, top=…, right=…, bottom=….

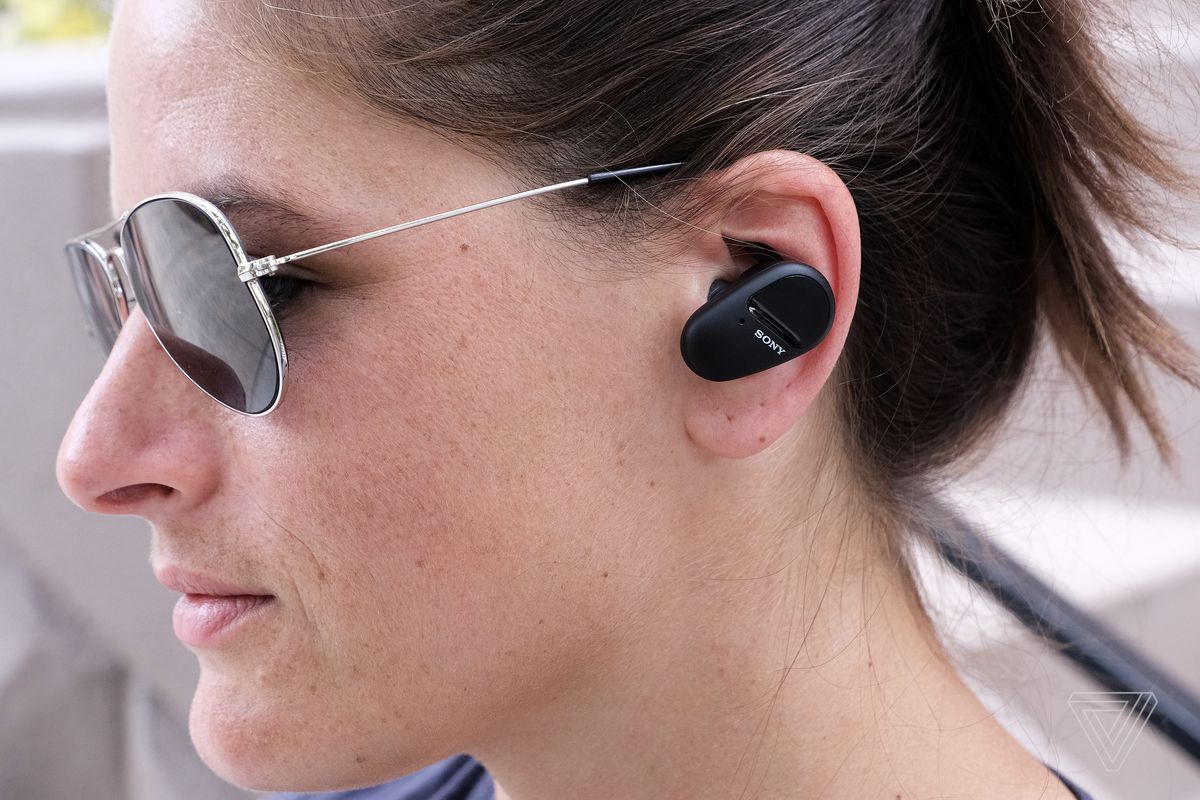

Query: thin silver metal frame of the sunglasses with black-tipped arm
left=66, top=162, right=683, bottom=416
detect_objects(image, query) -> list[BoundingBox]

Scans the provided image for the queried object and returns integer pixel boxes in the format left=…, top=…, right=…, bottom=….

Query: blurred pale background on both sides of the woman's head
left=0, top=0, right=1200, bottom=800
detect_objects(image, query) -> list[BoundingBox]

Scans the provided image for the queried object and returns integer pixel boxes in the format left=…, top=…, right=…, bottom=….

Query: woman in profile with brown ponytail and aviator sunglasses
left=58, top=0, right=1200, bottom=800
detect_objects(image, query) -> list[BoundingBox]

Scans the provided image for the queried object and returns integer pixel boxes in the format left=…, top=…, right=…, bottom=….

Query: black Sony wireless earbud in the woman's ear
left=679, top=255, right=834, bottom=380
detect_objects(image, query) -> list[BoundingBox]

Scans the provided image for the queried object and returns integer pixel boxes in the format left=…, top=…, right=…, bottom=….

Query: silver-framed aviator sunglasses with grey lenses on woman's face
left=66, top=162, right=682, bottom=416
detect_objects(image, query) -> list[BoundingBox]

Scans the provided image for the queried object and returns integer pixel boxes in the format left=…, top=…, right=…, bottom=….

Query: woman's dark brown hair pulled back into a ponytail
left=240, top=0, right=1200, bottom=532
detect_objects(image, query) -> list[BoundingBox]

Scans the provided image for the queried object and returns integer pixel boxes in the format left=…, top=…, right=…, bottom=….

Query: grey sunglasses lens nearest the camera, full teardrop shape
left=121, top=198, right=281, bottom=414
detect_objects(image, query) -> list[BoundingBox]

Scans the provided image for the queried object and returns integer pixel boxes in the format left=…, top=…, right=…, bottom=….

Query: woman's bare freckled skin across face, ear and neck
left=51, top=0, right=1080, bottom=800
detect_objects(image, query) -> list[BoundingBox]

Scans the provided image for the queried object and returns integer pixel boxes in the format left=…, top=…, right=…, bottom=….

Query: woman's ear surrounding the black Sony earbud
left=680, top=150, right=860, bottom=458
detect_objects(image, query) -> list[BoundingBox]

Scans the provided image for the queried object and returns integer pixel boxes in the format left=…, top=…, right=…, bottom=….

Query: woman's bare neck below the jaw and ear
left=470, top=465, right=1070, bottom=800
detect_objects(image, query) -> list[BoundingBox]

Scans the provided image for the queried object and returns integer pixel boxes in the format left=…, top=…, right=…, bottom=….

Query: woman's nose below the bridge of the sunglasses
left=55, top=307, right=223, bottom=522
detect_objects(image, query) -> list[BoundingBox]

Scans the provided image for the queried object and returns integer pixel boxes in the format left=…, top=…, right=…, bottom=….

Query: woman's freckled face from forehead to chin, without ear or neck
left=59, top=0, right=706, bottom=789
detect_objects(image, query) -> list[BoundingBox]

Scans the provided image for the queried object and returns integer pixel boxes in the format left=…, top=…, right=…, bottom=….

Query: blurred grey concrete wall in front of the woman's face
left=0, top=47, right=246, bottom=800
